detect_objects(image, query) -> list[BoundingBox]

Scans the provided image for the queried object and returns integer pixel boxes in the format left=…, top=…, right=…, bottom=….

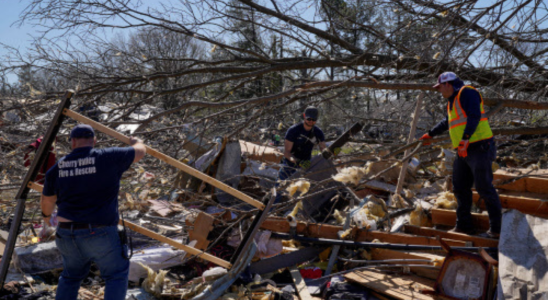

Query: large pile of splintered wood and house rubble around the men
left=0, top=99, right=548, bottom=299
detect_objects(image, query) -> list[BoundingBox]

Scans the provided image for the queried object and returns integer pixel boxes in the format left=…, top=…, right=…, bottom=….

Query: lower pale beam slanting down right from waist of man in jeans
left=29, top=182, right=232, bottom=269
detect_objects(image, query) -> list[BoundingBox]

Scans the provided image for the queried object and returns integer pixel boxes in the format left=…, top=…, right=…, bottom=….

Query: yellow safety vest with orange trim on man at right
left=447, top=85, right=493, bottom=148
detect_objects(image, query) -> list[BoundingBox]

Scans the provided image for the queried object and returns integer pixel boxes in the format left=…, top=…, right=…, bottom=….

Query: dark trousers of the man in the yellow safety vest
left=453, top=140, right=502, bottom=233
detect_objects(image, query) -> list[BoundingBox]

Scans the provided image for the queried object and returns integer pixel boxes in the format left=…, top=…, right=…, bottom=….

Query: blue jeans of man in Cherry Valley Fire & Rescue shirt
left=55, top=226, right=129, bottom=300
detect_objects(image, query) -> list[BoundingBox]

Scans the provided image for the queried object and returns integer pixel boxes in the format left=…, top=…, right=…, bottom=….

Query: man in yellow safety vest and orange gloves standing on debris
left=420, top=72, right=501, bottom=238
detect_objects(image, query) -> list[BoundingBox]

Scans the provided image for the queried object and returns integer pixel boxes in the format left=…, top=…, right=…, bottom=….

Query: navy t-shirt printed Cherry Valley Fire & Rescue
left=42, top=147, right=135, bottom=226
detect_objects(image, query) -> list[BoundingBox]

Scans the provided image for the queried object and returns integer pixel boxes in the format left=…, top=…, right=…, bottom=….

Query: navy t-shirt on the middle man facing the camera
left=285, top=123, right=325, bottom=160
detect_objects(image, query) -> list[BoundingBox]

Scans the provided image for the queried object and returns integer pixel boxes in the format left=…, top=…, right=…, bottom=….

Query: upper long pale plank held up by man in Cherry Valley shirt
left=63, top=109, right=265, bottom=210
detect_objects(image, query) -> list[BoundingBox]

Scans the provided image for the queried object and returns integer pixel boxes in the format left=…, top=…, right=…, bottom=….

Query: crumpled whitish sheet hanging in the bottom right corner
left=498, top=210, right=548, bottom=299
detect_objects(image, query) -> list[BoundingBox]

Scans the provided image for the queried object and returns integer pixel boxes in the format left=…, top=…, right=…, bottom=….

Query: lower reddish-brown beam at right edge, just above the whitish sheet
left=472, top=191, right=548, bottom=218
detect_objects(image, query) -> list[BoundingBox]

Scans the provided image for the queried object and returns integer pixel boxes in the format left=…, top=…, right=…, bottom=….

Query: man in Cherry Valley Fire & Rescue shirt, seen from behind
left=40, top=124, right=146, bottom=299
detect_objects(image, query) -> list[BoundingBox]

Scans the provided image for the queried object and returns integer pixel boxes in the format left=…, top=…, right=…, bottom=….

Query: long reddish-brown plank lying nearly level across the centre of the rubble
left=261, top=217, right=466, bottom=247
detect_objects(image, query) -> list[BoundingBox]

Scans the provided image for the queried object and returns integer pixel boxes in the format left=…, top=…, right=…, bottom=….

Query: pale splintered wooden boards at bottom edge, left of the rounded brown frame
left=344, top=270, right=434, bottom=300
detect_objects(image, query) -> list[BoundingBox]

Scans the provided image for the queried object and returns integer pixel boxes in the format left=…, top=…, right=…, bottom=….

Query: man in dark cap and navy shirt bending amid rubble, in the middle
left=276, top=106, right=326, bottom=202
